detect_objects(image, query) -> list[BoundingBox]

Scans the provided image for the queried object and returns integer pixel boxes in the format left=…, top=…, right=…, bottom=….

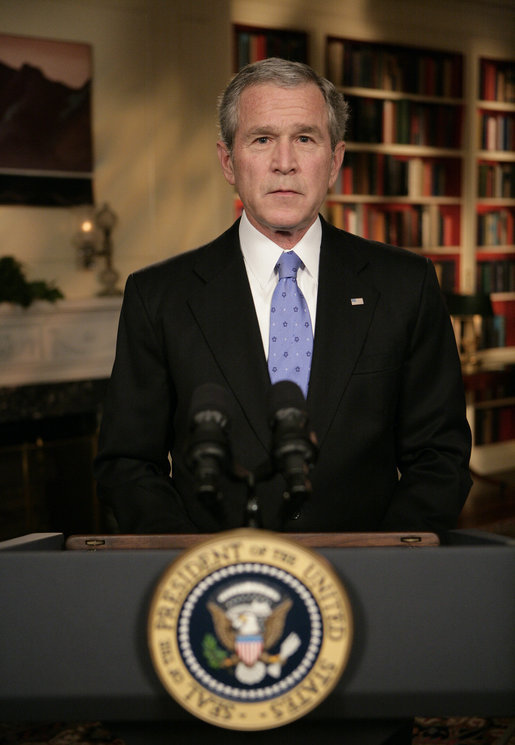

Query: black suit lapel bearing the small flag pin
left=308, top=218, right=379, bottom=444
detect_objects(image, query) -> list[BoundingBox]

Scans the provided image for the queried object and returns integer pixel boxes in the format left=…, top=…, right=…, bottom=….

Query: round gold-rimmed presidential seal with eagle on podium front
left=149, top=529, right=352, bottom=730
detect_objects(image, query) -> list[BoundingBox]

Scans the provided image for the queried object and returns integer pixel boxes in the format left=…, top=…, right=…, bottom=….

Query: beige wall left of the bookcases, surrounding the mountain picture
left=0, top=0, right=233, bottom=298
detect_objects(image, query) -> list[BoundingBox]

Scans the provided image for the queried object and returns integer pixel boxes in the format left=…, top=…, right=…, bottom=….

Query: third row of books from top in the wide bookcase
left=333, top=152, right=461, bottom=199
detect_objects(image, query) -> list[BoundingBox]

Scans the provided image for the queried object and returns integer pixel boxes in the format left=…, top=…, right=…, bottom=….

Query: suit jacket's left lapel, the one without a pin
left=189, top=224, right=270, bottom=447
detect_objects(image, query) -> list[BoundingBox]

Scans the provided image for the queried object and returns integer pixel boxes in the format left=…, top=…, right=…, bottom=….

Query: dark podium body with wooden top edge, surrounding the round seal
left=0, top=531, right=515, bottom=739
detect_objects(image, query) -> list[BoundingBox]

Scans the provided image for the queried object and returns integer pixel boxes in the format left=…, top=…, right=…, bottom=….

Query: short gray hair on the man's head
left=218, top=57, right=349, bottom=152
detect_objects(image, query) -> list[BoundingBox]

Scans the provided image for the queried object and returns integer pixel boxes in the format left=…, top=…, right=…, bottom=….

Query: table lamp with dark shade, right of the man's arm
left=446, top=293, right=493, bottom=372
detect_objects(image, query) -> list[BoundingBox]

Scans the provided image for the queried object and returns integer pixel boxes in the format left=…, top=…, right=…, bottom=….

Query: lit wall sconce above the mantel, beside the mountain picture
left=74, top=203, right=122, bottom=297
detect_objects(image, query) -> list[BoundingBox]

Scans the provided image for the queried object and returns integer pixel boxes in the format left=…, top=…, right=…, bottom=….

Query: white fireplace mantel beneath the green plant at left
left=0, top=297, right=122, bottom=387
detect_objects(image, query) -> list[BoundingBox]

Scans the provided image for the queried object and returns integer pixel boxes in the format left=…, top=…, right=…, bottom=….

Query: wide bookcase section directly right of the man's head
left=326, top=37, right=465, bottom=292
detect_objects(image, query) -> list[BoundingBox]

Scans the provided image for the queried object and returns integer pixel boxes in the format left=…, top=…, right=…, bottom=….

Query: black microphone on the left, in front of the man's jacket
left=186, top=383, right=231, bottom=506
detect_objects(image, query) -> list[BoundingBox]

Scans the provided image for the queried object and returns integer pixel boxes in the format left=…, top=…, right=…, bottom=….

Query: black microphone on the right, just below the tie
left=269, top=380, right=317, bottom=513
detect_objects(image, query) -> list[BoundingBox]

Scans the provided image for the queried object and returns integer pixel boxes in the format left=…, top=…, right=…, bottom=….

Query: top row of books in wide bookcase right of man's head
left=327, top=38, right=463, bottom=98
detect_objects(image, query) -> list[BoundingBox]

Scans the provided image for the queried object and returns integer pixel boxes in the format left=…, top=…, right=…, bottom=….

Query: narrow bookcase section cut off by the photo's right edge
left=468, top=55, right=515, bottom=472
